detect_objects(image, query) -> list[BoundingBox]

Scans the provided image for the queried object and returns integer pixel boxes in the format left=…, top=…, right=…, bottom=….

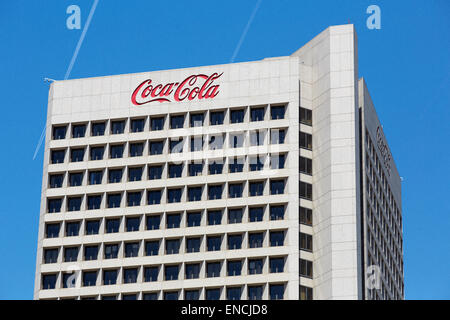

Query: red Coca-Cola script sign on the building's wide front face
left=131, top=72, right=223, bottom=106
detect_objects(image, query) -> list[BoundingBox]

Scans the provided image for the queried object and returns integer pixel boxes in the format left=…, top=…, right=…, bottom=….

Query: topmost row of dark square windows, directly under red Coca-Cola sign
left=52, top=105, right=292, bottom=140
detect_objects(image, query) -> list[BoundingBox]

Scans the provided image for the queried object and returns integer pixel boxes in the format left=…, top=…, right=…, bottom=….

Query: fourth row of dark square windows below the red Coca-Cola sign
left=47, top=179, right=288, bottom=213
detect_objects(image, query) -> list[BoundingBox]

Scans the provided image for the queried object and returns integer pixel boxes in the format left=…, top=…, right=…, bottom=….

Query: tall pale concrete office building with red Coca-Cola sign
left=34, top=25, right=404, bottom=300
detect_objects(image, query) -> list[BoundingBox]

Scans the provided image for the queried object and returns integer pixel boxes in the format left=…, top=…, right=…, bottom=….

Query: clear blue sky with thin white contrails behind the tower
left=0, top=0, right=450, bottom=299
